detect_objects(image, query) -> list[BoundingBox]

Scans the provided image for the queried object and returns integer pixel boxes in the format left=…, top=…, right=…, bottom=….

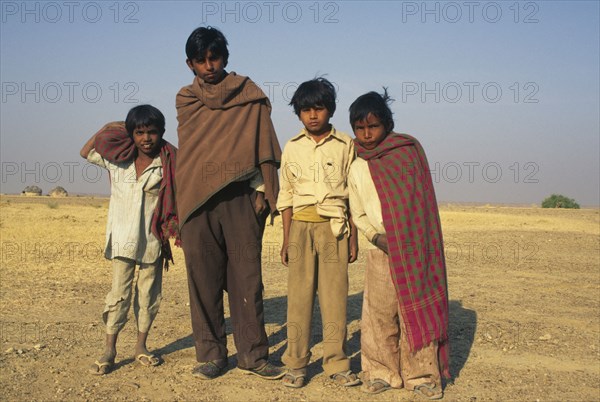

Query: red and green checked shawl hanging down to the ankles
left=356, top=133, right=450, bottom=377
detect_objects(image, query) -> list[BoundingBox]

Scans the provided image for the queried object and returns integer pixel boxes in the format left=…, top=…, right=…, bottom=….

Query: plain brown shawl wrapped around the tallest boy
left=175, top=72, right=281, bottom=226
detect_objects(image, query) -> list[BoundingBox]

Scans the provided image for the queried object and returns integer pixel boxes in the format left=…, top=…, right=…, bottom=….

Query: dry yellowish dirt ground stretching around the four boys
left=0, top=196, right=600, bottom=402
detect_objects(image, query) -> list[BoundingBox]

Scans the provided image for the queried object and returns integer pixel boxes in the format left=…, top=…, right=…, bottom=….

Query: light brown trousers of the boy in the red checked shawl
left=360, top=249, right=442, bottom=390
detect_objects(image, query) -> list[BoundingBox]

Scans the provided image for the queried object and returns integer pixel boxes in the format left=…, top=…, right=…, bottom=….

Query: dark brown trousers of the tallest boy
left=181, top=182, right=269, bottom=368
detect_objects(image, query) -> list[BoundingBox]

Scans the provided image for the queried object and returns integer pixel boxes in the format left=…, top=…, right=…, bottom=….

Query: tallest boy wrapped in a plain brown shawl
left=176, top=27, right=284, bottom=380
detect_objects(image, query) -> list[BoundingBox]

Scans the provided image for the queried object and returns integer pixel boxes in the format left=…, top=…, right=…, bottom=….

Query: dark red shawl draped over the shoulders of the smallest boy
left=94, top=122, right=181, bottom=269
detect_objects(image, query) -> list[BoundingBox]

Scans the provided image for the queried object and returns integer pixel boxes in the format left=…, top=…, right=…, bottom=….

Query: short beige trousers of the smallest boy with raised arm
left=102, top=257, right=162, bottom=335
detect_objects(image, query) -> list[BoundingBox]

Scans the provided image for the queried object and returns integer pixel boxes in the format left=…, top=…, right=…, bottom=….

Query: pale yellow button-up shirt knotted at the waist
left=277, top=127, right=355, bottom=237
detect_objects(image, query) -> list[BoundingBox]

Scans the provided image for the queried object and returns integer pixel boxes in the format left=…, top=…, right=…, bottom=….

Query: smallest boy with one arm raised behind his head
left=80, top=105, right=178, bottom=375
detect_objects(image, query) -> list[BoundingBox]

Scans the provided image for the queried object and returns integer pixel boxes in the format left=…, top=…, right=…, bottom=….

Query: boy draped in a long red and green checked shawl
left=348, top=91, right=449, bottom=399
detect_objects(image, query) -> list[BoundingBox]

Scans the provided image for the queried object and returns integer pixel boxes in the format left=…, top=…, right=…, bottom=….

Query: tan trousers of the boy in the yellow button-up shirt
left=282, top=221, right=350, bottom=375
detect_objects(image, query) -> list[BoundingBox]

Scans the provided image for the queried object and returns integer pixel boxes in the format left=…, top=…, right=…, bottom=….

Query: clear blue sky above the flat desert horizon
left=0, top=0, right=600, bottom=207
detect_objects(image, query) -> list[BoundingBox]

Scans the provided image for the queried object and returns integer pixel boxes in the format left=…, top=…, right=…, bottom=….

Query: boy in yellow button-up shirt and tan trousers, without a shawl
left=277, top=78, right=360, bottom=388
